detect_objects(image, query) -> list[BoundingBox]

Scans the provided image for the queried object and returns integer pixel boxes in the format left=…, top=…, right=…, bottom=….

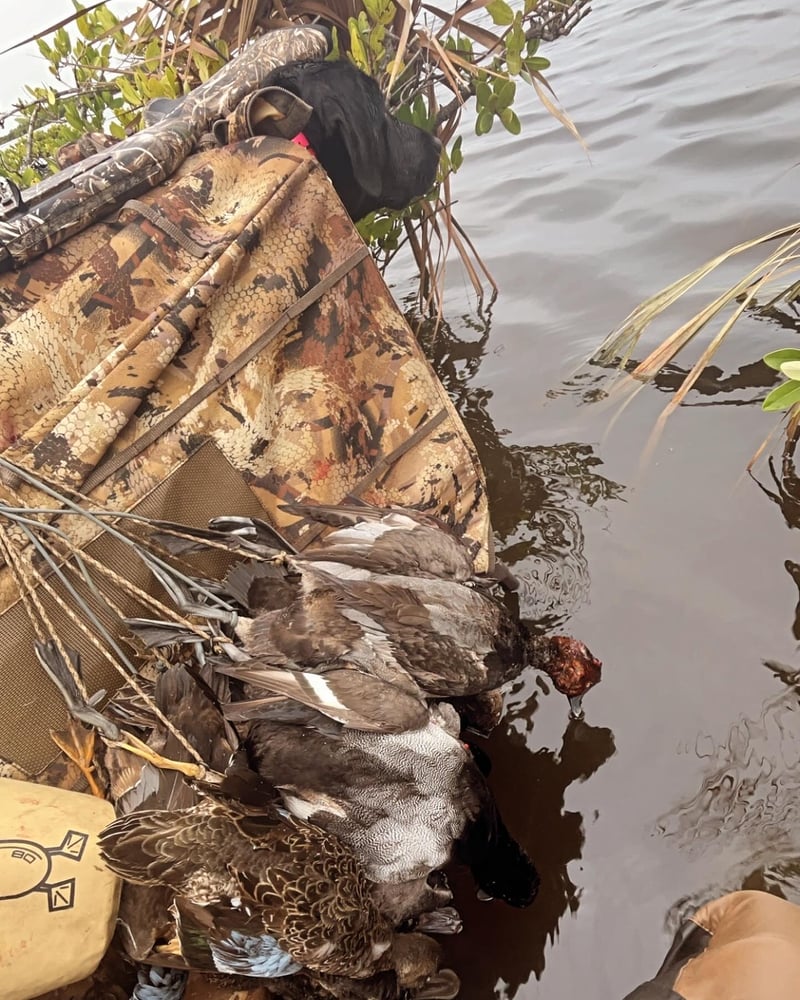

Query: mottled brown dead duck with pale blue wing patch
left=99, top=799, right=446, bottom=988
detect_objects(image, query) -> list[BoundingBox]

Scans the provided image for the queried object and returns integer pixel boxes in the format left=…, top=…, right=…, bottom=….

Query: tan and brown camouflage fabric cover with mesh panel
left=0, top=35, right=491, bottom=772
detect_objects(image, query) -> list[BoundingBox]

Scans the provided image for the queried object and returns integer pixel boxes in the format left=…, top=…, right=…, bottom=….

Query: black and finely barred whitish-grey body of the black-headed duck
left=248, top=708, right=477, bottom=883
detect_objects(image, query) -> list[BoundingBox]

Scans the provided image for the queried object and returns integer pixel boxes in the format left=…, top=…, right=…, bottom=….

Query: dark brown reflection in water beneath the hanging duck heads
left=447, top=706, right=615, bottom=1000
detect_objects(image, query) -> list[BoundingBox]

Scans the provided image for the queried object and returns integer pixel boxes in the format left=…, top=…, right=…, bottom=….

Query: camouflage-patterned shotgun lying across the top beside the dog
left=0, top=27, right=330, bottom=272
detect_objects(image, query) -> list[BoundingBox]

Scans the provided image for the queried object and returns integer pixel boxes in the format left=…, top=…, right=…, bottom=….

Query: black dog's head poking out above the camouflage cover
left=263, top=59, right=442, bottom=219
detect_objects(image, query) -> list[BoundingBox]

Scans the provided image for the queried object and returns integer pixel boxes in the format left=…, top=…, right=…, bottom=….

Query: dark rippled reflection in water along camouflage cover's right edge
left=409, top=308, right=623, bottom=628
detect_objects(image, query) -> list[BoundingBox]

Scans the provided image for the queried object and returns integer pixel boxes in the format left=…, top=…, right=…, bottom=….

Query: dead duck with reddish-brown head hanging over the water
left=225, top=556, right=602, bottom=715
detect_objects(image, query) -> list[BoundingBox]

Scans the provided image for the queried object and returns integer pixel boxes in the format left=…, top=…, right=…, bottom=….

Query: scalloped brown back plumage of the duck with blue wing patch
left=99, top=800, right=392, bottom=978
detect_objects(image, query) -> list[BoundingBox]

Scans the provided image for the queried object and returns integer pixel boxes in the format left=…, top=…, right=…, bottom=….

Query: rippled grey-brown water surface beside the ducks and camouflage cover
left=400, top=0, right=800, bottom=1000
